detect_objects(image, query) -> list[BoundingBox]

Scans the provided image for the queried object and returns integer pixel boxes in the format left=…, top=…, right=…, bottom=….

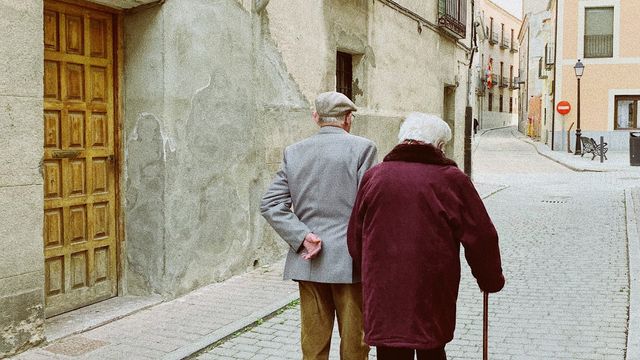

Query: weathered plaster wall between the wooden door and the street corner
left=123, top=0, right=467, bottom=296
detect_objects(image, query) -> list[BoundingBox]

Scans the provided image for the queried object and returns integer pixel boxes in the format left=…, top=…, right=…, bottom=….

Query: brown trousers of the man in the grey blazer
left=298, top=281, right=369, bottom=360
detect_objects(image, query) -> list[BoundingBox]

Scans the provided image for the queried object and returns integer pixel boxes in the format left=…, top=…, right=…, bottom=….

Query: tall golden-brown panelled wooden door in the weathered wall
left=43, top=1, right=118, bottom=316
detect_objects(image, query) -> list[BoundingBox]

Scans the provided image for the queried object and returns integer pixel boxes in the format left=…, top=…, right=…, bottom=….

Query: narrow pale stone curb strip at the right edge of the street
left=625, top=188, right=640, bottom=360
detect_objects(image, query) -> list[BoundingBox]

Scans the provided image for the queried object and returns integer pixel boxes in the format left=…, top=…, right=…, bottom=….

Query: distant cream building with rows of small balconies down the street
left=474, top=0, right=521, bottom=129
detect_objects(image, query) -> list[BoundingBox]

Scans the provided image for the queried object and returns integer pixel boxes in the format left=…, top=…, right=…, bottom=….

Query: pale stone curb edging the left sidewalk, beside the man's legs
left=162, top=291, right=300, bottom=360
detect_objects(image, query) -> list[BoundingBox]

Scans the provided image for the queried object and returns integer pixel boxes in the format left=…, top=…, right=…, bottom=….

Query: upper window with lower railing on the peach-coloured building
left=584, top=7, right=613, bottom=58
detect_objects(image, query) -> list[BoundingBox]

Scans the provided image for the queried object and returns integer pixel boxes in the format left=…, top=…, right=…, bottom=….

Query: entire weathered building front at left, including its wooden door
left=0, top=0, right=472, bottom=357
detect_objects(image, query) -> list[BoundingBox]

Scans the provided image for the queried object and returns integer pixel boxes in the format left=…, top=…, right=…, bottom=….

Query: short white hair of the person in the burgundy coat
left=398, top=112, right=451, bottom=145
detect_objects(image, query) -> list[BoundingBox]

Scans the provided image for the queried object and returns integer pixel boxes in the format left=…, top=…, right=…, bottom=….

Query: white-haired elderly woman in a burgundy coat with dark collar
left=348, top=113, right=505, bottom=360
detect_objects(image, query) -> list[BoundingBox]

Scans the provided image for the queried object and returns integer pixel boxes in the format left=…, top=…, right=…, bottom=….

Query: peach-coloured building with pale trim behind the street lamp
left=550, top=0, right=640, bottom=150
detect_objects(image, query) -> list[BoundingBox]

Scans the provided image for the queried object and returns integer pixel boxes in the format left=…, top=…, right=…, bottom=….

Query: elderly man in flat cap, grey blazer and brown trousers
left=260, top=92, right=376, bottom=360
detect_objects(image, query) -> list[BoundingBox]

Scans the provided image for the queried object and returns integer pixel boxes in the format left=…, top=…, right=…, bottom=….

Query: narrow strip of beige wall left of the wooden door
left=0, top=0, right=44, bottom=358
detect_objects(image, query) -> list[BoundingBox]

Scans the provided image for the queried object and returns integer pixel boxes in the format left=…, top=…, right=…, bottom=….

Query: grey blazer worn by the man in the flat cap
left=260, top=126, right=377, bottom=284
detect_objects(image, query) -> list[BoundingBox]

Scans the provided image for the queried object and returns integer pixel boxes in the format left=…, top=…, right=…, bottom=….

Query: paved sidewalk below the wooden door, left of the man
left=14, top=262, right=298, bottom=360
